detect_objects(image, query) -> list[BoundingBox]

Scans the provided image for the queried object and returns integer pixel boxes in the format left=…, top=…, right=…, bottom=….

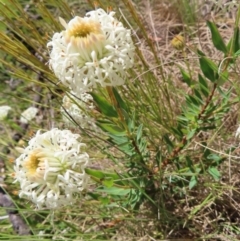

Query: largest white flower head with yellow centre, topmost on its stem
left=47, top=9, right=135, bottom=94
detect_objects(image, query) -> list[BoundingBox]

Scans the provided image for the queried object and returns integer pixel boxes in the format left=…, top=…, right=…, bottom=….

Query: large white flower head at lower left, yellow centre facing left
left=14, top=129, right=89, bottom=208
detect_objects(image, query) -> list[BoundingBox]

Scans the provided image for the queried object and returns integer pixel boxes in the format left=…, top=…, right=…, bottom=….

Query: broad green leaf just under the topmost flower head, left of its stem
left=91, top=93, right=118, bottom=117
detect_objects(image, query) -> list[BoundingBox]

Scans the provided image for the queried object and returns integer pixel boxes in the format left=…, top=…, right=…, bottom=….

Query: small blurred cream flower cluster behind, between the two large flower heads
left=61, top=93, right=97, bottom=129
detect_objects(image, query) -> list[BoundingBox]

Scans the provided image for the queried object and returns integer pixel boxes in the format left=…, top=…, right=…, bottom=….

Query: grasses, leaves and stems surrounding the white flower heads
left=0, top=0, right=240, bottom=240
